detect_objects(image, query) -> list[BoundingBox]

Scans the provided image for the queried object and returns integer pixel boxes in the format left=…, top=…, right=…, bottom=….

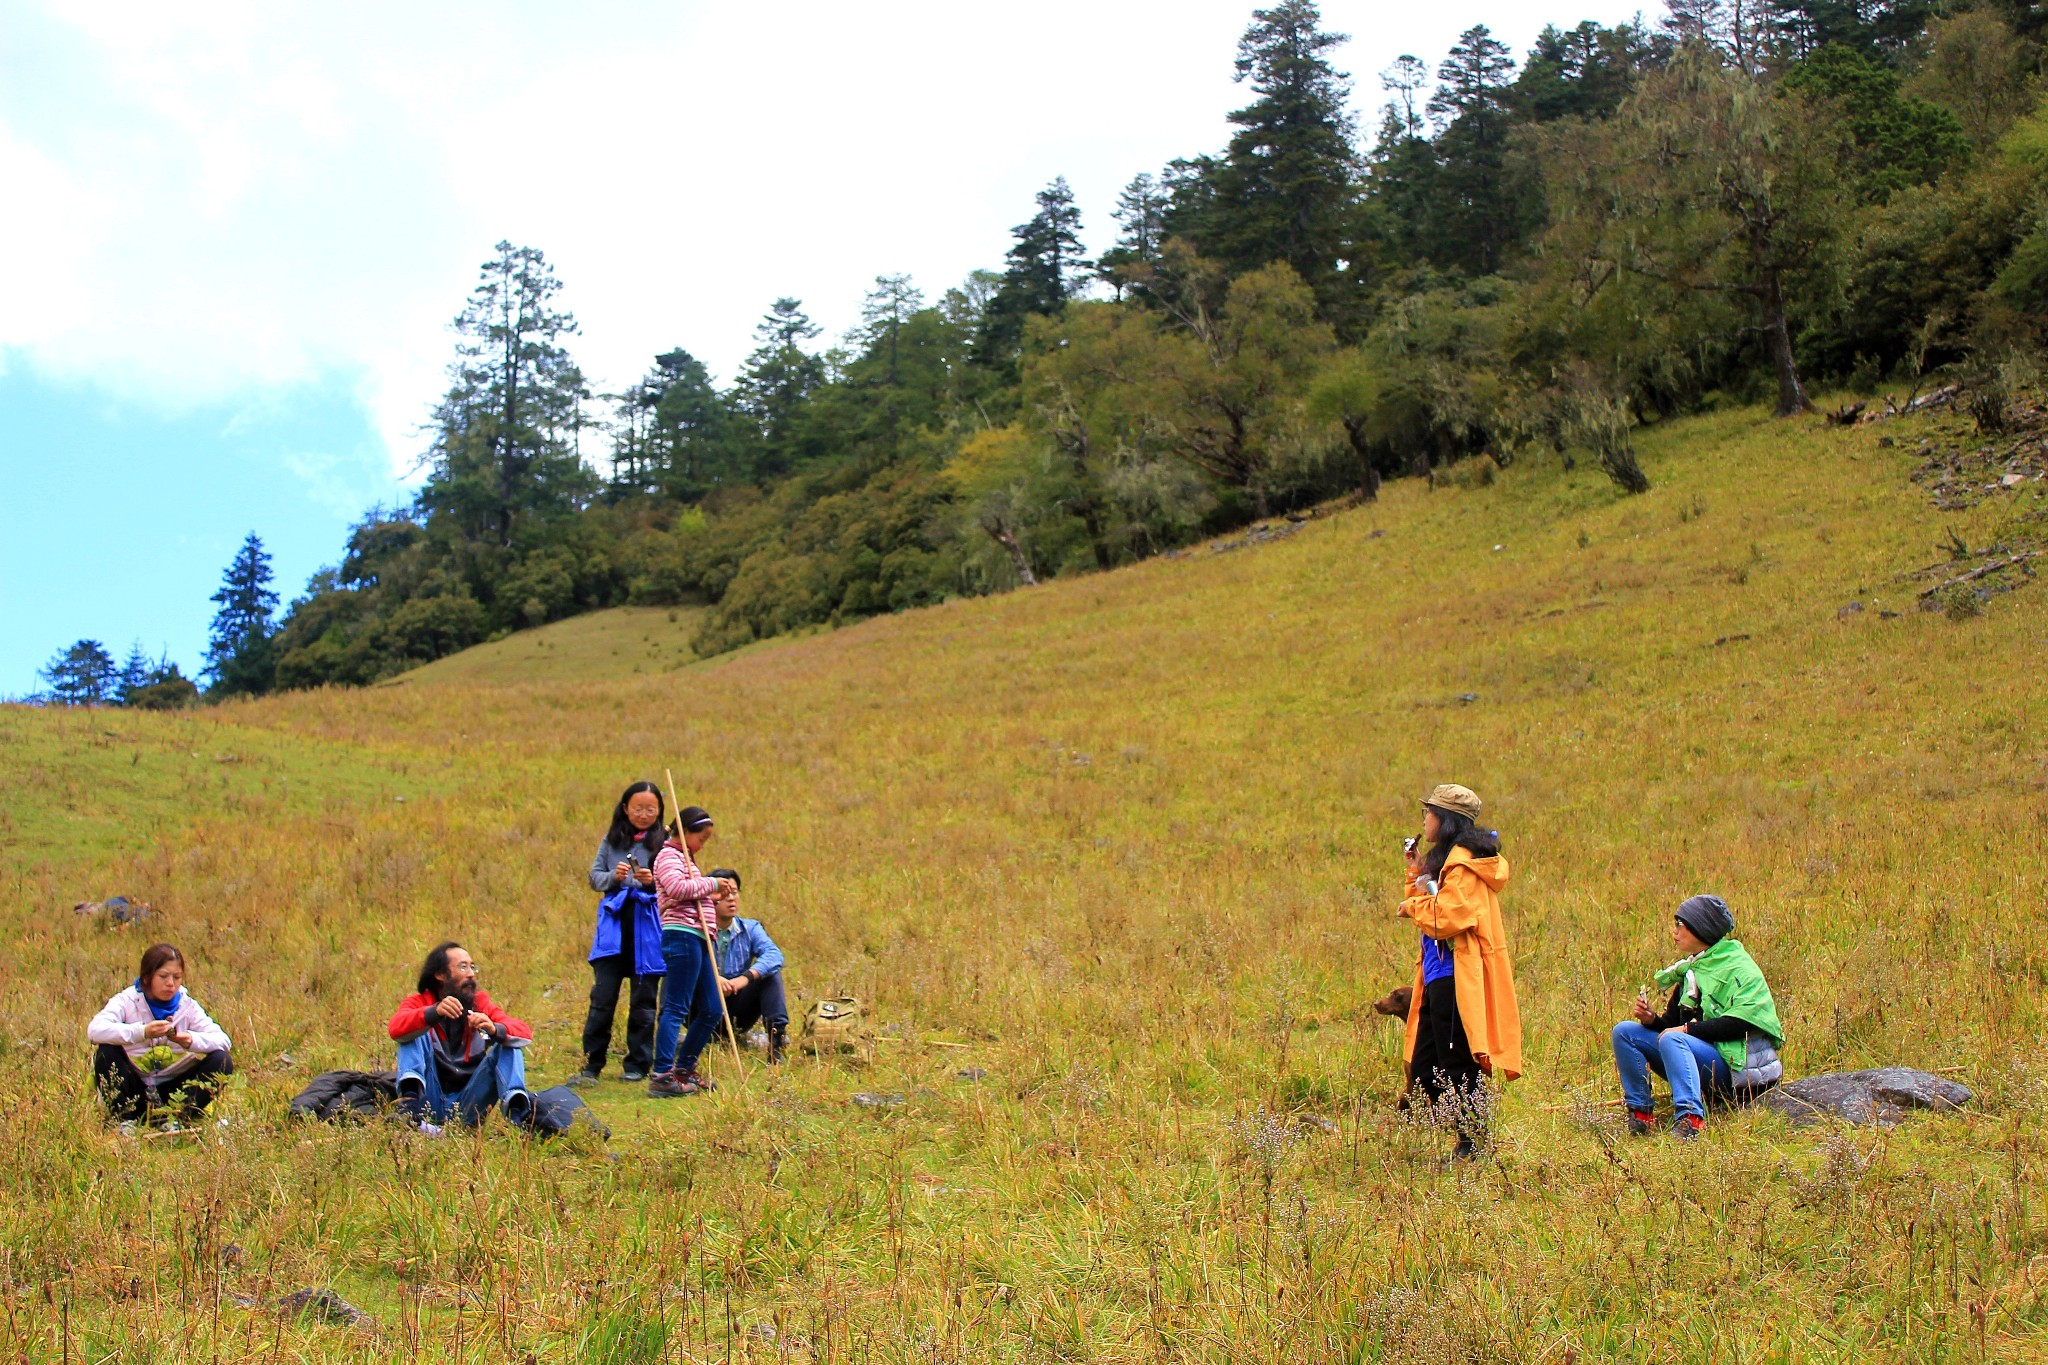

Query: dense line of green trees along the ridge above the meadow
left=32, top=0, right=2048, bottom=700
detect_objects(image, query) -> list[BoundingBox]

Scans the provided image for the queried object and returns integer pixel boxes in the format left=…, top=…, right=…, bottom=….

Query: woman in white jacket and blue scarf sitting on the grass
left=86, top=943, right=236, bottom=1119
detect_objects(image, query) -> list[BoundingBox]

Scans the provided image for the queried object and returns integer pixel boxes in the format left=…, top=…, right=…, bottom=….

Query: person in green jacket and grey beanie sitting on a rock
left=1614, top=896, right=1786, bottom=1140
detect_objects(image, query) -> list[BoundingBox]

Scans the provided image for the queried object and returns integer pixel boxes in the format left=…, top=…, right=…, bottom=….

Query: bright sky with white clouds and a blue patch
left=0, top=0, right=1636, bottom=694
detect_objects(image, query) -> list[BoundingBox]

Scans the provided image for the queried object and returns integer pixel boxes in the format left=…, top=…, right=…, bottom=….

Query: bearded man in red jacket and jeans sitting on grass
left=391, top=943, right=532, bottom=1134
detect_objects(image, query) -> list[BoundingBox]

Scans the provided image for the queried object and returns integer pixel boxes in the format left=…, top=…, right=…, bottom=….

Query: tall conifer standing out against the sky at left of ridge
left=420, top=241, right=592, bottom=546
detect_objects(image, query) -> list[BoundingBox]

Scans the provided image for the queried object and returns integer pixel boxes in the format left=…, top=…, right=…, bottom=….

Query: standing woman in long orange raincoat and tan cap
left=1401, top=782, right=1522, bottom=1156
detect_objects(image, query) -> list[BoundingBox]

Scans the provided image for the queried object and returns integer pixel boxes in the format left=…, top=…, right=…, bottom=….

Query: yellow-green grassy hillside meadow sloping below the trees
left=0, top=401, right=2048, bottom=1361
